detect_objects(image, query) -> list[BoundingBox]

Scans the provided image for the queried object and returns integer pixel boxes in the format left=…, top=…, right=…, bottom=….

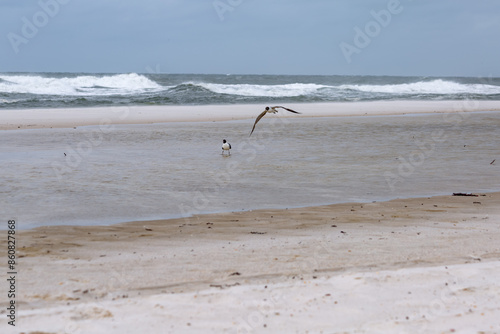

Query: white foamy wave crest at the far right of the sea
left=339, top=79, right=500, bottom=95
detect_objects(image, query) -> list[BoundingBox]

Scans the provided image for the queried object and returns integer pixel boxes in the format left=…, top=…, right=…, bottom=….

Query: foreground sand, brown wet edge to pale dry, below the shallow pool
left=0, top=193, right=500, bottom=333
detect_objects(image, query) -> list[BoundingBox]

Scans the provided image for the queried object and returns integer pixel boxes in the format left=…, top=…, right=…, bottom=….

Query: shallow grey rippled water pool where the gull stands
left=0, top=112, right=500, bottom=229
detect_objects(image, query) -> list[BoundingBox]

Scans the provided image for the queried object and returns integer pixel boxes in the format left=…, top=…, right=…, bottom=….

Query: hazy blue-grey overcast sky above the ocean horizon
left=0, top=0, right=500, bottom=77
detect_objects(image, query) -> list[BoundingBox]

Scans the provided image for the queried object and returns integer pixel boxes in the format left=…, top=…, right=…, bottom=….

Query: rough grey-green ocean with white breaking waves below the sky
left=0, top=73, right=500, bottom=109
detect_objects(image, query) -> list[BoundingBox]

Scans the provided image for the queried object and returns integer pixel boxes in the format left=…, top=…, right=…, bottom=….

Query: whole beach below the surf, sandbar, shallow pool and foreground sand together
left=0, top=101, right=500, bottom=333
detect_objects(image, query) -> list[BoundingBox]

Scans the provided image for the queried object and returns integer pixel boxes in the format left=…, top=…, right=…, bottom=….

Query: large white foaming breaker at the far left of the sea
left=0, top=73, right=163, bottom=95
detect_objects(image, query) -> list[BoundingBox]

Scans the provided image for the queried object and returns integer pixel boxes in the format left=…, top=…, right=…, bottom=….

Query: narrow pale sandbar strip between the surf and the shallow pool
left=0, top=100, right=500, bottom=130
